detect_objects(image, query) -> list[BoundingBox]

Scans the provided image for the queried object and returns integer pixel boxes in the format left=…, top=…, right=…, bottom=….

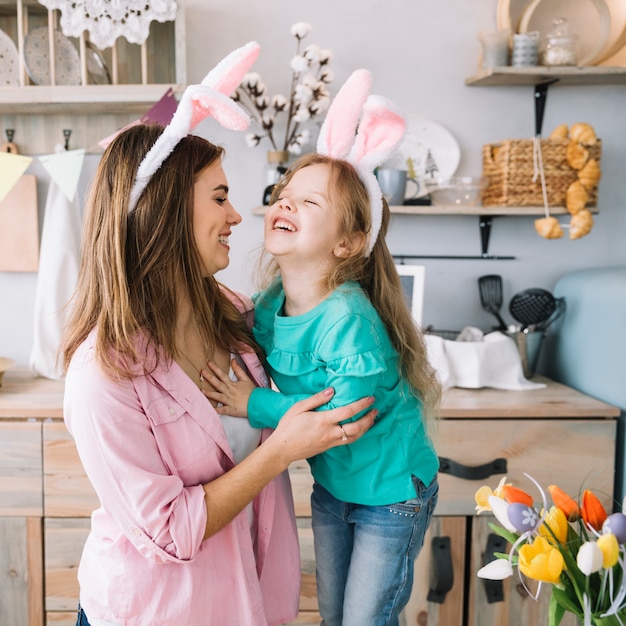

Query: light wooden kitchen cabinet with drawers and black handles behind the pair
left=0, top=370, right=619, bottom=626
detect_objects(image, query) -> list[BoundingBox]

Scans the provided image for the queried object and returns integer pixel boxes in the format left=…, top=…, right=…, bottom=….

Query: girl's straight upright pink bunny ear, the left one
left=317, top=69, right=372, bottom=159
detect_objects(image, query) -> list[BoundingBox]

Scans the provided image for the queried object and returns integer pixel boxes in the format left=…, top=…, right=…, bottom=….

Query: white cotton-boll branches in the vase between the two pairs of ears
left=232, top=22, right=334, bottom=154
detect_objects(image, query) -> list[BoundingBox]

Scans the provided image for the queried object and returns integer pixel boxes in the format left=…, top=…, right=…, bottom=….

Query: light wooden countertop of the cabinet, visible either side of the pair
left=0, top=368, right=620, bottom=420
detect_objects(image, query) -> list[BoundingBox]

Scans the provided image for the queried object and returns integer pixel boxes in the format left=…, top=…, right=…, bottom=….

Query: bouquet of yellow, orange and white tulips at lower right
left=475, top=474, right=626, bottom=626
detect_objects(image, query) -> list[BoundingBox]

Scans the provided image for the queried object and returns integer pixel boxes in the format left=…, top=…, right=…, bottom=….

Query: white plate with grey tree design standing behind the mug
left=385, top=115, right=461, bottom=197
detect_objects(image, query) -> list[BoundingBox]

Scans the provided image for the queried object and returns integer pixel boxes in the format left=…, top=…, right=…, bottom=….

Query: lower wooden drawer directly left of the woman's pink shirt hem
left=44, top=518, right=91, bottom=621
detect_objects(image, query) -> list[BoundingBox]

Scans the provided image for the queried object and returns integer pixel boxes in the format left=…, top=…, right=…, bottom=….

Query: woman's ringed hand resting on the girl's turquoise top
left=263, top=388, right=378, bottom=465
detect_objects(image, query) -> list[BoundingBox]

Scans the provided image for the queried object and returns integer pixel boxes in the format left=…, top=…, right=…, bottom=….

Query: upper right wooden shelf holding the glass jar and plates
left=465, top=65, right=626, bottom=87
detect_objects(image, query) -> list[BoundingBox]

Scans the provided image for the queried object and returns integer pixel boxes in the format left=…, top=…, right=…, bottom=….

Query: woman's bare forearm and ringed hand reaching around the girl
left=203, top=389, right=376, bottom=539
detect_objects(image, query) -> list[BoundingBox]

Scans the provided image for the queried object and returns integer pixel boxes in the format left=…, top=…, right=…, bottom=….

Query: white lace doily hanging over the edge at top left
left=39, top=0, right=176, bottom=49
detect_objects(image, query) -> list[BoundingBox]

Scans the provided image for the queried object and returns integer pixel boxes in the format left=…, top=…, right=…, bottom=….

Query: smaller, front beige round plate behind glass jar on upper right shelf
left=519, top=0, right=608, bottom=65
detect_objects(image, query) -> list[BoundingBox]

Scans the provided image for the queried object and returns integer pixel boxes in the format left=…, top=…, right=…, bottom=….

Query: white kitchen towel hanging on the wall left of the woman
left=30, top=180, right=82, bottom=380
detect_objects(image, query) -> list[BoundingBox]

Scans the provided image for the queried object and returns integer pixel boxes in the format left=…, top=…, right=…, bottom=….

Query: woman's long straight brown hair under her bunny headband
left=61, top=125, right=254, bottom=378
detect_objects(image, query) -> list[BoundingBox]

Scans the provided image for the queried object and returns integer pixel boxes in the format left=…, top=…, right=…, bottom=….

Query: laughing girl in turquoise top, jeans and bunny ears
left=203, top=70, right=440, bottom=626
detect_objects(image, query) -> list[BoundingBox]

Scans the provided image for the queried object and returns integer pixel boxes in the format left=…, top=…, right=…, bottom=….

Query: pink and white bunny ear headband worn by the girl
left=317, top=69, right=406, bottom=256
